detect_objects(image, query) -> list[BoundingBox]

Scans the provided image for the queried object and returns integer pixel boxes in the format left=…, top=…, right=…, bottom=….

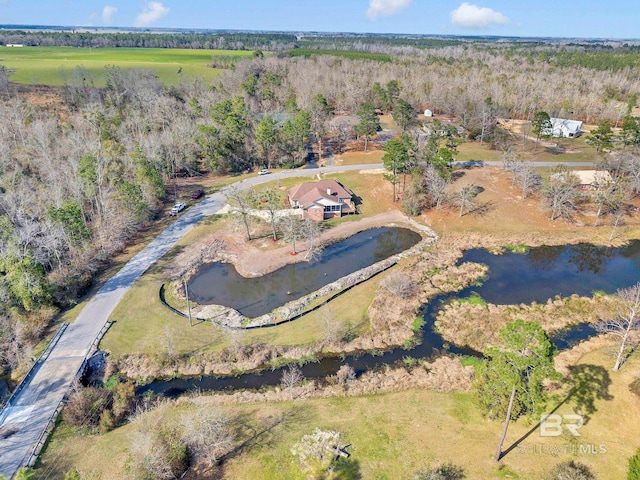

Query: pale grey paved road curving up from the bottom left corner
left=0, top=164, right=382, bottom=477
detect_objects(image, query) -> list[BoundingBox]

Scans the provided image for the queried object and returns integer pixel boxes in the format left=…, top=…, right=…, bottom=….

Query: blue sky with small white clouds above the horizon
left=0, top=0, right=640, bottom=39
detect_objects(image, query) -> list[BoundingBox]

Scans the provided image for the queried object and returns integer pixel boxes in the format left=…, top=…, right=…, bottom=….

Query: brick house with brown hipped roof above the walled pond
left=288, top=179, right=356, bottom=222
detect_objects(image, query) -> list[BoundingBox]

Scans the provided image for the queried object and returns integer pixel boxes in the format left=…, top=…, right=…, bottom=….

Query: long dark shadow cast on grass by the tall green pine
left=500, top=364, right=613, bottom=458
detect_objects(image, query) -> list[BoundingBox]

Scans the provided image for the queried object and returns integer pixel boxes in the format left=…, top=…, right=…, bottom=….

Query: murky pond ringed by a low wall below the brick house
left=189, top=227, right=421, bottom=318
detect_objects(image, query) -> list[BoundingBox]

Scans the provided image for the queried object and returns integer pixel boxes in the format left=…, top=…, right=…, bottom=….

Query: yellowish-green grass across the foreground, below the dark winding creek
left=39, top=350, right=640, bottom=480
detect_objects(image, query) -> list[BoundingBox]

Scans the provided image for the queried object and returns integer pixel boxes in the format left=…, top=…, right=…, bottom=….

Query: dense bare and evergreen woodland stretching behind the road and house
left=0, top=33, right=640, bottom=378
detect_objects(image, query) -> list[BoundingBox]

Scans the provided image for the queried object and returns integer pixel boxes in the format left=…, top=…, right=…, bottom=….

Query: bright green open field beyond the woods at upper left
left=0, top=47, right=252, bottom=86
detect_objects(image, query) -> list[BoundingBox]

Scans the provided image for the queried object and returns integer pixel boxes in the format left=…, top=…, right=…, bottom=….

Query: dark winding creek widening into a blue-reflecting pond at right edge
left=138, top=241, right=640, bottom=397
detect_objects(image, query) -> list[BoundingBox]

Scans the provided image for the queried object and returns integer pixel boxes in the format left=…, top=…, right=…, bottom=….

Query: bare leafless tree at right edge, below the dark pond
left=598, top=282, right=640, bottom=372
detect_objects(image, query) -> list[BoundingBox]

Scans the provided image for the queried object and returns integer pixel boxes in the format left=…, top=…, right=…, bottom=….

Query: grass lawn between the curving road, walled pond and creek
left=100, top=216, right=384, bottom=358
